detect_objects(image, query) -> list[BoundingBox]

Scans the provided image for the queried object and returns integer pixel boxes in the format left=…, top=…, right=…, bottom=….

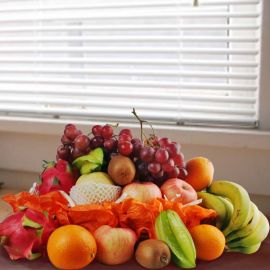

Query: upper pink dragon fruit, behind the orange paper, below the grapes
left=37, top=159, right=77, bottom=195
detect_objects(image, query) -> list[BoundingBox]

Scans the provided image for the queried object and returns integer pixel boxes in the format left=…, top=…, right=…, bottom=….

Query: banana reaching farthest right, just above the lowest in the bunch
left=227, top=212, right=269, bottom=249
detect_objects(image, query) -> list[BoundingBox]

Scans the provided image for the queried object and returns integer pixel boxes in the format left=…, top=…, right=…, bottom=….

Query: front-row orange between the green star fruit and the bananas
left=190, top=224, right=225, bottom=261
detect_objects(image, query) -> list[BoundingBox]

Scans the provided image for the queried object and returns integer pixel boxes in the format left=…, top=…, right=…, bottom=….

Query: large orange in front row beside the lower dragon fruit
left=47, top=225, right=97, bottom=269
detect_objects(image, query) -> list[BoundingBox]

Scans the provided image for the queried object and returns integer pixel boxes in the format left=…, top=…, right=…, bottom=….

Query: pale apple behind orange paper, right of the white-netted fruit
left=121, top=182, right=162, bottom=203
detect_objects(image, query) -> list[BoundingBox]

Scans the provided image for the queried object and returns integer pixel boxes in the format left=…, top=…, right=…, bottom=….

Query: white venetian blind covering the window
left=0, top=0, right=262, bottom=127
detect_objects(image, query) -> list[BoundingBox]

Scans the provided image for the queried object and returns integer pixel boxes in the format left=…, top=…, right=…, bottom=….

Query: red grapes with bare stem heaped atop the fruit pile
left=57, top=113, right=187, bottom=186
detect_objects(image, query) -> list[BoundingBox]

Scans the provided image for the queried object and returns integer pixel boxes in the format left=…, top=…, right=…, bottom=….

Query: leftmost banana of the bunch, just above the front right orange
left=197, top=192, right=230, bottom=229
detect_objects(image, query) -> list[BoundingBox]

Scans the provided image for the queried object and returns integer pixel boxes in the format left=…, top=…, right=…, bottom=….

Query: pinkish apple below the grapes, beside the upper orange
left=160, top=178, right=197, bottom=204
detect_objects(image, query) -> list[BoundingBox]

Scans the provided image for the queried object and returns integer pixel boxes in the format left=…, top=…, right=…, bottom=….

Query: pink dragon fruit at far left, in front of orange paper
left=0, top=208, right=55, bottom=260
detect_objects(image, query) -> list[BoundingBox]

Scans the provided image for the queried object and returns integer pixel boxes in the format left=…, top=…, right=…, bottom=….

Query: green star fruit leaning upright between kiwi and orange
left=155, top=210, right=196, bottom=268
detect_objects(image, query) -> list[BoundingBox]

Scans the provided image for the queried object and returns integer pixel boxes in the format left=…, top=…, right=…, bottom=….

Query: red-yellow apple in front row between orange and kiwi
left=94, top=225, right=137, bottom=265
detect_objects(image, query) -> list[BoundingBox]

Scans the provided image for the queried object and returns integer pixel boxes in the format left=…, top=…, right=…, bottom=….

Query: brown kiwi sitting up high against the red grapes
left=108, top=155, right=136, bottom=186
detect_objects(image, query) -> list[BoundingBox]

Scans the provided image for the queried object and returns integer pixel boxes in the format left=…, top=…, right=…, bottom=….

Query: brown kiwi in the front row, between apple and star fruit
left=135, top=239, right=171, bottom=269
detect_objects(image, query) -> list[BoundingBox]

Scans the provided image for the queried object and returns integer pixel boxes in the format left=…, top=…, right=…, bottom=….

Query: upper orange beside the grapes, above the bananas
left=185, top=157, right=214, bottom=191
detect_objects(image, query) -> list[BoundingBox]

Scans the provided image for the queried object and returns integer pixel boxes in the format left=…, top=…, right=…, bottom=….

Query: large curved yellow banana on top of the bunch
left=208, top=180, right=250, bottom=236
